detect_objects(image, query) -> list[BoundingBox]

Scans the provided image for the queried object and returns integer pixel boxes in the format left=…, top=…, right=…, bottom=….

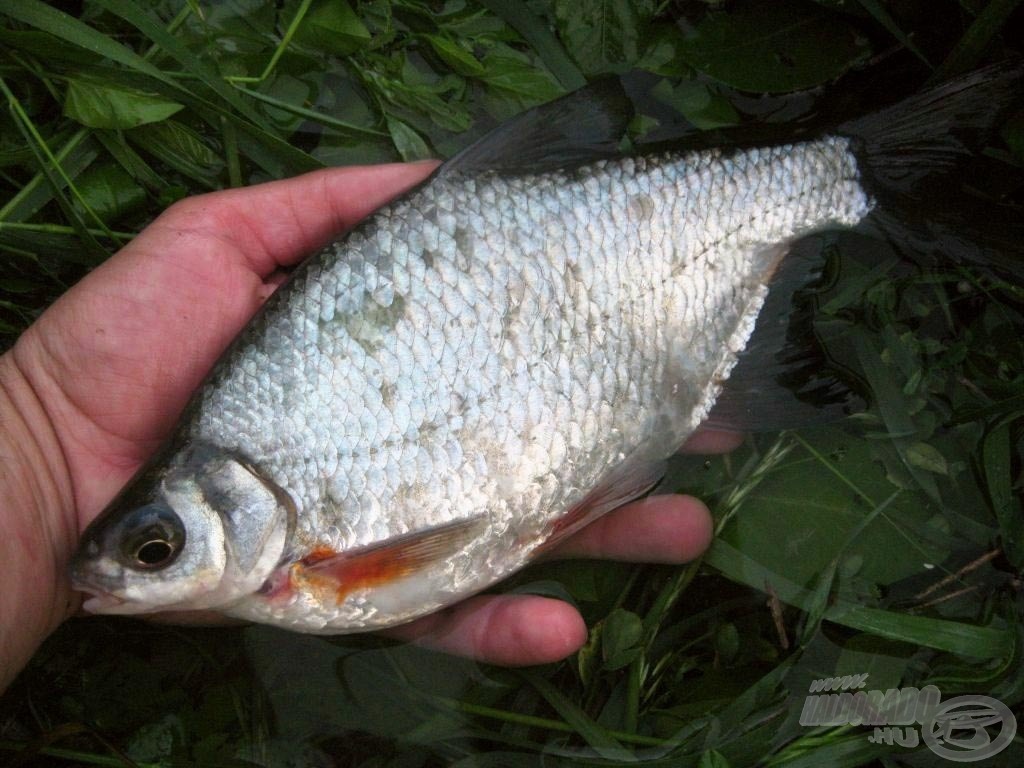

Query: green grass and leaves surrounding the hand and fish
left=0, top=0, right=1024, bottom=768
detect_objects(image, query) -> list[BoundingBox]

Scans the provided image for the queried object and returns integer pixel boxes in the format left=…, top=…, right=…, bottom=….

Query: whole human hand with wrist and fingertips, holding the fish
left=0, top=163, right=737, bottom=688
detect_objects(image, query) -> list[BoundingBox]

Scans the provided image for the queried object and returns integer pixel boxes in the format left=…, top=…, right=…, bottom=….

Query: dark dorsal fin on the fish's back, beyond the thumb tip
left=437, top=78, right=633, bottom=176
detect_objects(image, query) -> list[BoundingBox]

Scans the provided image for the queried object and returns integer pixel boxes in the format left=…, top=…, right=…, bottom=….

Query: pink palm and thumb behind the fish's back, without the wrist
left=15, top=166, right=427, bottom=526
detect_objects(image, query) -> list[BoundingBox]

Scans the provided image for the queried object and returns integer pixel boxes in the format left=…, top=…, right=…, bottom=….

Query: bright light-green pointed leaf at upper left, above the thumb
left=63, top=78, right=184, bottom=129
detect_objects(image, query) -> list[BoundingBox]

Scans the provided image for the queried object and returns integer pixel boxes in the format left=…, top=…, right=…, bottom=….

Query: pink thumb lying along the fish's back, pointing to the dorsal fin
left=136, top=161, right=437, bottom=278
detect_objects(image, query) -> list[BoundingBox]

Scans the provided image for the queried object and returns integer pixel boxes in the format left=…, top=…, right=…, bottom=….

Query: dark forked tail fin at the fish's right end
left=838, top=60, right=1024, bottom=276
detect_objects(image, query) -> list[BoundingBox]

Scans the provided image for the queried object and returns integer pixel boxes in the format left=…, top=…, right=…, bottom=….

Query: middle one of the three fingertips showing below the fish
left=549, top=496, right=714, bottom=563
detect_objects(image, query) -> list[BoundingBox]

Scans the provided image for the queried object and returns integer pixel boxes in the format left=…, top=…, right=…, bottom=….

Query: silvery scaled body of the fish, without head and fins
left=172, top=138, right=869, bottom=629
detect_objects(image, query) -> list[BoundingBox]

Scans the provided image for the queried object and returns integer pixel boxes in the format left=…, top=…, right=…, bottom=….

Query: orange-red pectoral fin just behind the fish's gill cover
left=290, top=517, right=483, bottom=602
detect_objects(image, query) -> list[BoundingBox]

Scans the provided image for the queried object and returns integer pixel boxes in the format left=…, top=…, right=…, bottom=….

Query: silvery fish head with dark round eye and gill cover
left=72, top=445, right=295, bottom=613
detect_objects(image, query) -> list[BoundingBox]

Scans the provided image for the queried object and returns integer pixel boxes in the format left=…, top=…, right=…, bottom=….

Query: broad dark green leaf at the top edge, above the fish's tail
left=679, top=3, right=870, bottom=93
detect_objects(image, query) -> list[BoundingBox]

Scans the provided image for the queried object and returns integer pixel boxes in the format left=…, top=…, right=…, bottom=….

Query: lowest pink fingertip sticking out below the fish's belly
left=383, top=595, right=587, bottom=667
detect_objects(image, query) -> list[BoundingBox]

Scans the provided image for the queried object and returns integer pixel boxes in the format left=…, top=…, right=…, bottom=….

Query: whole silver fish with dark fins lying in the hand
left=71, top=66, right=1021, bottom=634
